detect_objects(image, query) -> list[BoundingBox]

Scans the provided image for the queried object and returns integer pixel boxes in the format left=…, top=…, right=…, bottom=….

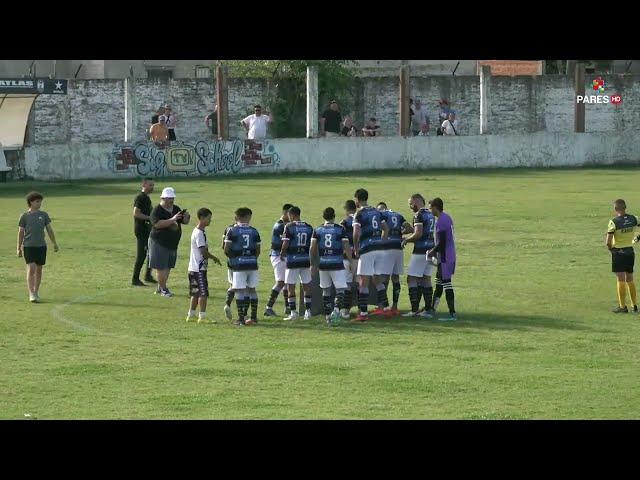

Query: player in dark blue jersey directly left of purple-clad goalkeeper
left=402, top=193, right=436, bottom=318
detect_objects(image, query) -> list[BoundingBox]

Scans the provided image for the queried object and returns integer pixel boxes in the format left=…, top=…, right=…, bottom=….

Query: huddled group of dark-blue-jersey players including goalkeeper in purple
left=212, top=189, right=456, bottom=325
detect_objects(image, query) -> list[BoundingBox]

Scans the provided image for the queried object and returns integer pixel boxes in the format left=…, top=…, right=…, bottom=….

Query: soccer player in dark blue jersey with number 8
left=311, top=207, right=351, bottom=325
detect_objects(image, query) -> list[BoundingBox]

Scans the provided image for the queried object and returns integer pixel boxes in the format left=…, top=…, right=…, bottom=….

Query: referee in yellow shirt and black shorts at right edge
left=607, top=198, right=640, bottom=313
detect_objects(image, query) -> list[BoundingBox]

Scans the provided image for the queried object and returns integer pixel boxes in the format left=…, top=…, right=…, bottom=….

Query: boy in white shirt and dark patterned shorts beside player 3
left=187, top=208, right=222, bottom=323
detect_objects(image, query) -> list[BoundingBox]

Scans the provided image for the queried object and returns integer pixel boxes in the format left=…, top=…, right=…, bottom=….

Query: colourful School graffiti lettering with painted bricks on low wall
left=109, top=140, right=280, bottom=177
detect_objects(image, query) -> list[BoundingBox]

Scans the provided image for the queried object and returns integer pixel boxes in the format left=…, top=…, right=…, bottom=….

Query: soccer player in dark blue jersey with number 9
left=376, top=202, right=411, bottom=315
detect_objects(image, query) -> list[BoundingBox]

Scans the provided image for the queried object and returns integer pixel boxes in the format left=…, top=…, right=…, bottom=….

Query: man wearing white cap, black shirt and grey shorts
left=149, top=187, right=191, bottom=297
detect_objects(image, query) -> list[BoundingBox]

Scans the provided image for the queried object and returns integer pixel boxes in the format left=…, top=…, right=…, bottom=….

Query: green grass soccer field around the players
left=0, top=168, right=640, bottom=419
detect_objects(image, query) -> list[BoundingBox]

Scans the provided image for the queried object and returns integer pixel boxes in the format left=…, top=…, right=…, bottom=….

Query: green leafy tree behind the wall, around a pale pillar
left=222, top=60, right=357, bottom=137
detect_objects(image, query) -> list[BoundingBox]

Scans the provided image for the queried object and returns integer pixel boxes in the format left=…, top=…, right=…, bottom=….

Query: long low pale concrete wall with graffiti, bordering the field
left=25, top=132, right=640, bottom=180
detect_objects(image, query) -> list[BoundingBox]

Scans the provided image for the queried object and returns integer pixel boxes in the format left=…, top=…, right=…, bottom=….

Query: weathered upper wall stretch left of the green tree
left=31, top=79, right=268, bottom=145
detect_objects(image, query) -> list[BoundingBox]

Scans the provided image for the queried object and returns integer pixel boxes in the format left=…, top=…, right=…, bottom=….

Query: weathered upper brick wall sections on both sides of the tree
left=32, top=75, right=640, bottom=144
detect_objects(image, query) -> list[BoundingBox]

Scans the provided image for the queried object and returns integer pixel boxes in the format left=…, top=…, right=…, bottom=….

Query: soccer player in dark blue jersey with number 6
left=353, top=188, right=392, bottom=322
